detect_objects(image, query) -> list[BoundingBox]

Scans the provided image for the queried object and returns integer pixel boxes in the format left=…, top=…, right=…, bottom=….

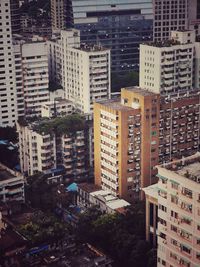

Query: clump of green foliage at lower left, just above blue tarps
left=18, top=211, right=69, bottom=244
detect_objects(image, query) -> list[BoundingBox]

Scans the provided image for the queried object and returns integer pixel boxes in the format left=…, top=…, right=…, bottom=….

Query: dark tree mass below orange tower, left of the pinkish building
left=77, top=202, right=153, bottom=267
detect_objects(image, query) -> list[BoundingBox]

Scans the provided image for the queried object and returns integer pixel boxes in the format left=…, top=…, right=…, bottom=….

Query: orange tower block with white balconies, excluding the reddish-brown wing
left=94, top=87, right=159, bottom=202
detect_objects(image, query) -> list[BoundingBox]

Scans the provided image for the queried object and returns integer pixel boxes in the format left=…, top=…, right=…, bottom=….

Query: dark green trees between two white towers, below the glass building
left=111, top=71, right=139, bottom=92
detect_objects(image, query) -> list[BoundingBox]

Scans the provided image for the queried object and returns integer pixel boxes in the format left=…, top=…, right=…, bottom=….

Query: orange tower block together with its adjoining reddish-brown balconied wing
left=94, top=87, right=200, bottom=202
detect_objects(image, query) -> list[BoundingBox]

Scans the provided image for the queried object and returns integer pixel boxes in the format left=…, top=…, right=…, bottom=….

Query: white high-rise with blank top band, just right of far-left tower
left=22, top=42, right=49, bottom=116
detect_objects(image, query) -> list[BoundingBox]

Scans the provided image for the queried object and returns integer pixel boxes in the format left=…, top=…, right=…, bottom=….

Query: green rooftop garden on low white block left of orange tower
left=34, top=114, right=85, bottom=134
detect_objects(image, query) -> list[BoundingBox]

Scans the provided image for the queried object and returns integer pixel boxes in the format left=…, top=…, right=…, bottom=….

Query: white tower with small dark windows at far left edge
left=0, top=0, right=17, bottom=127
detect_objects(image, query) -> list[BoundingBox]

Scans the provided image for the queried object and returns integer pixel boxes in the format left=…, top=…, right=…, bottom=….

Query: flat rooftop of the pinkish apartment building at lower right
left=160, top=152, right=200, bottom=183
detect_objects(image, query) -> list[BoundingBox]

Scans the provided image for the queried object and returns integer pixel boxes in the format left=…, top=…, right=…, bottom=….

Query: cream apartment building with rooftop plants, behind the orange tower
left=140, top=31, right=195, bottom=96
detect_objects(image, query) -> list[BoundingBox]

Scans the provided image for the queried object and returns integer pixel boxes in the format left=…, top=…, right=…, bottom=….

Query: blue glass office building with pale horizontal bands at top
left=65, top=0, right=153, bottom=75
